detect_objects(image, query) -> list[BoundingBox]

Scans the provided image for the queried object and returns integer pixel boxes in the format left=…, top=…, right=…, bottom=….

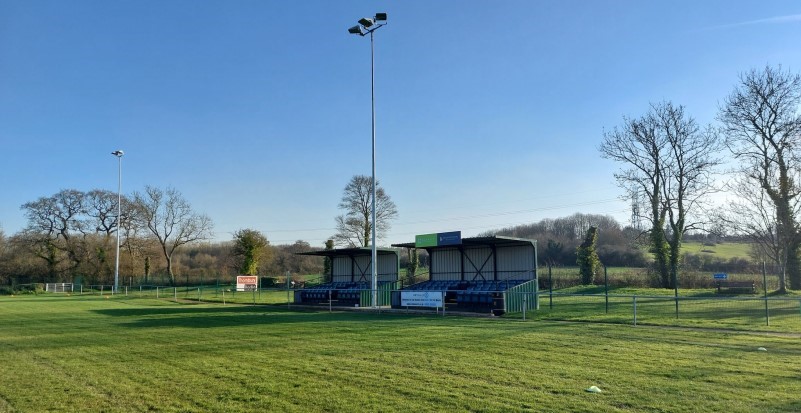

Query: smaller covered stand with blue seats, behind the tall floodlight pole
left=295, top=247, right=400, bottom=307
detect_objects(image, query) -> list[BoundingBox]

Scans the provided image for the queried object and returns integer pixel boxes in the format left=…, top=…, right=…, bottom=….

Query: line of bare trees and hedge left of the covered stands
left=0, top=187, right=323, bottom=285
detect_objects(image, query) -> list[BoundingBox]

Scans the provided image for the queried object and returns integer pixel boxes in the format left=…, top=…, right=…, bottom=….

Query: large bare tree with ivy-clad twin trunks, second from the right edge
left=599, top=102, right=721, bottom=288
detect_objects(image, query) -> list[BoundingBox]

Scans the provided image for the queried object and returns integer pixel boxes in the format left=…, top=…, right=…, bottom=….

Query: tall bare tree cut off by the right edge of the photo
left=718, top=66, right=801, bottom=289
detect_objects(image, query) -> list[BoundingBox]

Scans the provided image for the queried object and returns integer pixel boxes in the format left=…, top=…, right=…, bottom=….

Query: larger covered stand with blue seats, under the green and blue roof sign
left=392, top=236, right=539, bottom=313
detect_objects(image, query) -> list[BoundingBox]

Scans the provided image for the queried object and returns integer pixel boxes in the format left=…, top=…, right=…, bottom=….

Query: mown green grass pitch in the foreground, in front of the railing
left=0, top=295, right=801, bottom=413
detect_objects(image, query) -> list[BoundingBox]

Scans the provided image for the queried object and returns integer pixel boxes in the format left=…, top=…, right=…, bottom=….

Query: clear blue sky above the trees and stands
left=0, top=0, right=801, bottom=246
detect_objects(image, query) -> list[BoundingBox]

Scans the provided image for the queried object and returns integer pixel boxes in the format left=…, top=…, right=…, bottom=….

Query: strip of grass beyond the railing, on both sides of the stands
left=70, top=285, right=801, bottom=333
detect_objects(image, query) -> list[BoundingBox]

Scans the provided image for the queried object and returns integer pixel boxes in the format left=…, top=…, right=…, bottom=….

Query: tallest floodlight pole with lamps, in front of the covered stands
left=348, top=13, right=387, bottom=307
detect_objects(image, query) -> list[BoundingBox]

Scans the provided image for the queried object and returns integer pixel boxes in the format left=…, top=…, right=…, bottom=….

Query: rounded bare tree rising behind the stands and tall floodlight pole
left=333, top=175, right=398, bottom=247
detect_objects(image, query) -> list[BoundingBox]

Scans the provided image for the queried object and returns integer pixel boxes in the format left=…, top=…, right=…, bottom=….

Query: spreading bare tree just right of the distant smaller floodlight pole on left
left=134, top=186, right=213, bottom=284
